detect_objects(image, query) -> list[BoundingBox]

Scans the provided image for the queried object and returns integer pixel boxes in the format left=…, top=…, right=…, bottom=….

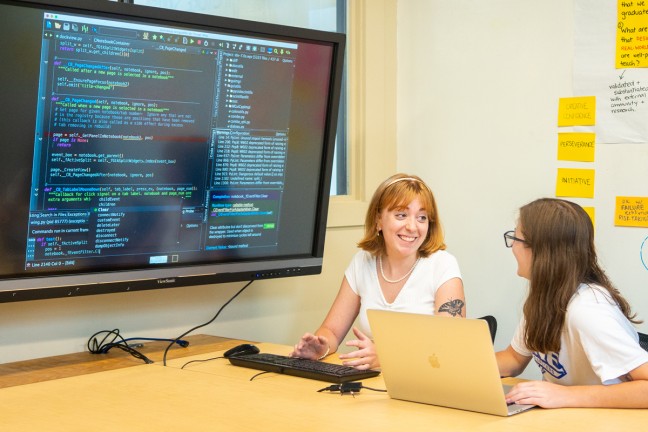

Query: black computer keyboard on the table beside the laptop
left=228, top=353, right=380, bottom=383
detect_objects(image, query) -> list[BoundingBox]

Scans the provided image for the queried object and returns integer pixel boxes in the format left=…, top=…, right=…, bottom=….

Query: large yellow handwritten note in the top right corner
left=616, top=0, right=648, bottom=69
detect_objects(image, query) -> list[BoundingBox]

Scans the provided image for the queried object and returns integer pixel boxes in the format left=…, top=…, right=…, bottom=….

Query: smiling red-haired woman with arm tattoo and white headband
left=291, top=174, right=466, bottom=369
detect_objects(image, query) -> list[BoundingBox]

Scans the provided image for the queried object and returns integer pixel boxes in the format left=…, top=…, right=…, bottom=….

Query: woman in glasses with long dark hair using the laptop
left=497, top=198, right=648, bottom=408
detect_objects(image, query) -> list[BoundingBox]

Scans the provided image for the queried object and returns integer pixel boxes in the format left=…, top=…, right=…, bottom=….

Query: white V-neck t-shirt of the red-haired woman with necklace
left=344, top=250, right=461, bottom=337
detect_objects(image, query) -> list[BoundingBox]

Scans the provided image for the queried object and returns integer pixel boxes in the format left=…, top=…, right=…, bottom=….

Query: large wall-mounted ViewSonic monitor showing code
left=0, top=0, right=345, bottom=302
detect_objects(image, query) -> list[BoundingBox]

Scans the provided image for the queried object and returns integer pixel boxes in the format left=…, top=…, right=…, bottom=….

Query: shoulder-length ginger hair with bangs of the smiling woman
left=358, top=174, right=446, bottom=257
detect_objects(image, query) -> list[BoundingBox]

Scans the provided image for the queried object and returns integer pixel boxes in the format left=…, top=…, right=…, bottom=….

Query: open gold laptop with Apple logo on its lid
left=367, top=310, right=534, bottom=416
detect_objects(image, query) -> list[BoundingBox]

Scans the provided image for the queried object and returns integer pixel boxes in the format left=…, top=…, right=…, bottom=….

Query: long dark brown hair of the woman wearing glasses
left=519, top=198, right=639, bottom=353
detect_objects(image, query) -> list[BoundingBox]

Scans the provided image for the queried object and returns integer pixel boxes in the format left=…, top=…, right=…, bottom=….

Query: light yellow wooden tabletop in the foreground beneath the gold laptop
left=0, top=344, right=648, bottom=432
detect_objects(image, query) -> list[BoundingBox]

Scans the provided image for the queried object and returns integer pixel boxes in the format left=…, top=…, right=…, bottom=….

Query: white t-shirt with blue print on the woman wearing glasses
left=511, top=284, right=648, bottom=385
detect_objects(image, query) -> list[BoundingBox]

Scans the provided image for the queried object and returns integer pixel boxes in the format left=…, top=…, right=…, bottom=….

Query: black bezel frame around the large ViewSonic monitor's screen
left=0, top=0, right=346, bottom=302
